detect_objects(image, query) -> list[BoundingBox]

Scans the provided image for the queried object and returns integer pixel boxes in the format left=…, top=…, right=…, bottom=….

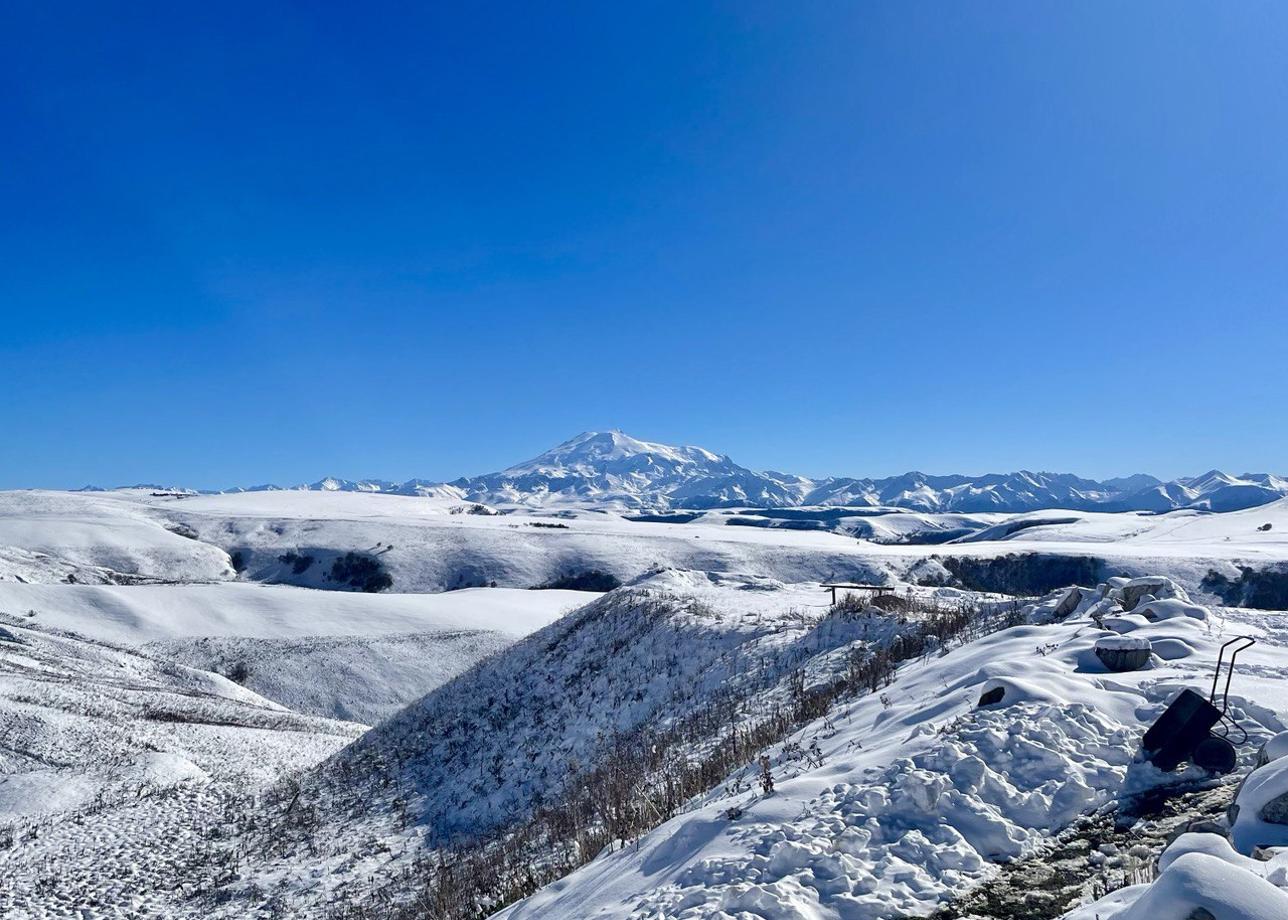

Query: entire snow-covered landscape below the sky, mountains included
left=0, top=432, right=1288, bottom=920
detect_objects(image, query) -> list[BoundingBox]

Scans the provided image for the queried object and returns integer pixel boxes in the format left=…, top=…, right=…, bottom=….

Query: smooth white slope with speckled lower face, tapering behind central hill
left=0, top=584, right=598, bottom=724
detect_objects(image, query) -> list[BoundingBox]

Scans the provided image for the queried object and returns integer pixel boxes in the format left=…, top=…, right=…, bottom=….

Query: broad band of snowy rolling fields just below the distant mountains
left=10, top=491, right=1288, bottom=599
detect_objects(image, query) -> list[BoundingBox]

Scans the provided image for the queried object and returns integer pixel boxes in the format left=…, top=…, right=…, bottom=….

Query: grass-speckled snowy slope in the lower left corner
left=0, top=616, right=361, bottom=920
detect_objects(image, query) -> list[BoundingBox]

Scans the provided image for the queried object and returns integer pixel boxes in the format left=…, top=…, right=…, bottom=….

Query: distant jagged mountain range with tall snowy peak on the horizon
left=77, top=430, right=1288, bottom=513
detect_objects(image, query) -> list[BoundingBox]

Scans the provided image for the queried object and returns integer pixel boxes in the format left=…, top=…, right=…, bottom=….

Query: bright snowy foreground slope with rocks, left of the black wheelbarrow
left=498, top=579, right=1288, bottom=920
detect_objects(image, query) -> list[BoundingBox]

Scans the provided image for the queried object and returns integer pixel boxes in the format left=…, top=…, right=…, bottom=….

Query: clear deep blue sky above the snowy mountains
left=0, top=0, right=1288, bottom=487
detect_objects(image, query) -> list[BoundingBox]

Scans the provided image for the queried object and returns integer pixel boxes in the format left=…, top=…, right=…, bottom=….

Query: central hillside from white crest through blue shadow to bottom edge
left=208, top=572, right=927, bottom=916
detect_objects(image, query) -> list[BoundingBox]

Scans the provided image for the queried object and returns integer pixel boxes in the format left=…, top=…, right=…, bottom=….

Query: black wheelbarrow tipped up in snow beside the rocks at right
left=1141, top=635, right=1257, bottom=773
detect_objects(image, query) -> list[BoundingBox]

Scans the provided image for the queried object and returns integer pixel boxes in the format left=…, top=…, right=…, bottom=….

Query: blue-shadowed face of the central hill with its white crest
left=322, top=572, right=844, bottom=838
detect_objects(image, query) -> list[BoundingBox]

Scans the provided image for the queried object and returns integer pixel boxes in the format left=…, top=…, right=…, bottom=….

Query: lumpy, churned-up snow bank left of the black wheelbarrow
left=628, top=704, right=1136, bottom=920
